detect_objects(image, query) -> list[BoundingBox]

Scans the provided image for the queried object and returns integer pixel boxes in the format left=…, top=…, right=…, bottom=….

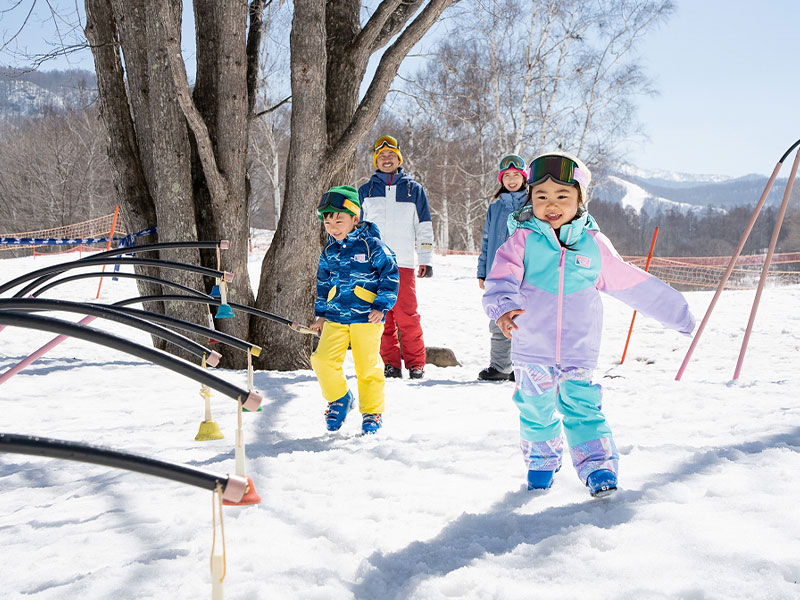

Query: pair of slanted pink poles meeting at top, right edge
left=675, top=140, right=800, bottom=381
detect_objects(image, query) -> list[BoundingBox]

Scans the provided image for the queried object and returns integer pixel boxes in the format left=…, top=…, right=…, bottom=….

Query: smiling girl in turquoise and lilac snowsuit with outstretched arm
left=483, top=152, right=694, bottom=496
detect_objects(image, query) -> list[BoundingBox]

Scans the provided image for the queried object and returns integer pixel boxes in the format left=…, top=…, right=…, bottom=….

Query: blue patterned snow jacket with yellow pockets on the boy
left=314, top=221, right=400, bottom=325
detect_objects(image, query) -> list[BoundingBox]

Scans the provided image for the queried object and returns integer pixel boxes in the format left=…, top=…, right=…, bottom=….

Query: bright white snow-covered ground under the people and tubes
left=0, top=250, right=800, bottom=600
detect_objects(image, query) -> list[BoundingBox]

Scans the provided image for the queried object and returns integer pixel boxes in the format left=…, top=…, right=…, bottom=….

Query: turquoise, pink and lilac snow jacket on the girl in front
left=483, top=213, right=695, bottom=369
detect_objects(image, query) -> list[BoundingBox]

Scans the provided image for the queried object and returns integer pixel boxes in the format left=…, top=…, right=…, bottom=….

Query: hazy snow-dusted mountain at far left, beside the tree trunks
left=0, top=67, right=97, bottom=120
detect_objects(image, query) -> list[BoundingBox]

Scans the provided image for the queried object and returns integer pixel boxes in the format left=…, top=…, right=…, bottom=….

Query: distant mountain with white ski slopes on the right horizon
left=592, top=169, right=800, bottom=214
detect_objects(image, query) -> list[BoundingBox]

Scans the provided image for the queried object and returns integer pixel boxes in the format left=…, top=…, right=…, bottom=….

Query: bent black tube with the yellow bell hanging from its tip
left=0, top=298, right=211, bottom=357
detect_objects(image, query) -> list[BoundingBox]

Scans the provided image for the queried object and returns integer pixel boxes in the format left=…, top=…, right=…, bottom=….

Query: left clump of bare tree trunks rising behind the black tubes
left=86, top=0, right=263, bottom=367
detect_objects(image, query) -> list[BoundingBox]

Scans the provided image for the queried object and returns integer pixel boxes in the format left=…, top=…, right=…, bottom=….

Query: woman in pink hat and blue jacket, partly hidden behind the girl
left=478, top=154, right=528, bottom=381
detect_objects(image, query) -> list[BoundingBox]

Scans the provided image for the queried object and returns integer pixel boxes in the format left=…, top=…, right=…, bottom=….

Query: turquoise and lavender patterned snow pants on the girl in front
left=514, top=363, right=619, bottom=484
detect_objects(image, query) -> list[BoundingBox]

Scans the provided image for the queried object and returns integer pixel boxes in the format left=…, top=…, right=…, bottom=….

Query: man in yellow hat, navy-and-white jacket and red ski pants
left=358, top=135, right=433, bottom=379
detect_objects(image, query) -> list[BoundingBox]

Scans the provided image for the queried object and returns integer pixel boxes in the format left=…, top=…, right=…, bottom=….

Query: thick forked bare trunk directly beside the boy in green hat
left=251, top=0, right=453, bottom=370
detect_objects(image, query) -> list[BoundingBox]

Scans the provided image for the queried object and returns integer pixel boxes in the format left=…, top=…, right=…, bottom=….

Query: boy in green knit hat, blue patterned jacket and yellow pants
left=310, top=186, right=399, bottom=434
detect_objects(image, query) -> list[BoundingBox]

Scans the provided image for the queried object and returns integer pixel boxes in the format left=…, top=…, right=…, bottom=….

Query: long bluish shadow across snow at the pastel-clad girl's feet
left=352, top=427, right=800, bottom=600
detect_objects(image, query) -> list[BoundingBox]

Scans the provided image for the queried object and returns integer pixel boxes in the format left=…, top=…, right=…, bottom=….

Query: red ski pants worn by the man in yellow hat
left=381, top=267, right=425, bottom=369
